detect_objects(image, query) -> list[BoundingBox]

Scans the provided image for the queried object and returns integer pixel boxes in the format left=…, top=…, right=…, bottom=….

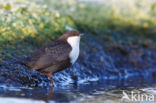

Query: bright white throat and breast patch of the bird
left=67, top=36, right=80, bottom=64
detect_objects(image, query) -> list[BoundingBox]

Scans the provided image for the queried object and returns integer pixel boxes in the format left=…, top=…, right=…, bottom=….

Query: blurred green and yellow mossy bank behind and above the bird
left=0, top=0, right=156, bottom=59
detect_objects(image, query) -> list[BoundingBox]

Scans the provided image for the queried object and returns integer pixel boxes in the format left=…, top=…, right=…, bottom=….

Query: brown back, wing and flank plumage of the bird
left=22, top=40, right=72, bottom=72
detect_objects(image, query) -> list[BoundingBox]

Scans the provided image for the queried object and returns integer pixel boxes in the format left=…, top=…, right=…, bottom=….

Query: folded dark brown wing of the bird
left=24, top=41, right=72, bottom=70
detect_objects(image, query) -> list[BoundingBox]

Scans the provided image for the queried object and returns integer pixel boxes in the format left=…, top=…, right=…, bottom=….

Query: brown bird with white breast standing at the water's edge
left=16, top=30, right=84, bottom=87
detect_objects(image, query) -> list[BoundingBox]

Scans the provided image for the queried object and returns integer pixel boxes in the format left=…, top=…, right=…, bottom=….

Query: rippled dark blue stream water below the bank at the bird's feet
left=0, top=80, right=156, bottom=103
